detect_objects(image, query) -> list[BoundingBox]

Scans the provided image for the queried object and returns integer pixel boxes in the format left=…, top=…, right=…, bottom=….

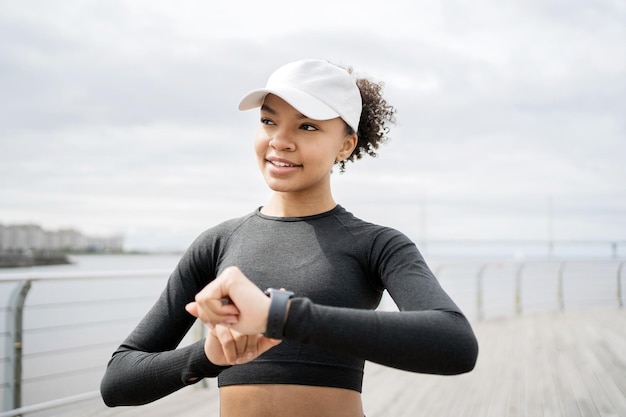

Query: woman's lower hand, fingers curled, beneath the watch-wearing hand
left=204, top=324, right=280, bottom=366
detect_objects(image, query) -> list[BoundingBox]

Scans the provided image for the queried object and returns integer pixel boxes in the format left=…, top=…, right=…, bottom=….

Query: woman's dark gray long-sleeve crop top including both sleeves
left=101, top=206, right=478, bottom=406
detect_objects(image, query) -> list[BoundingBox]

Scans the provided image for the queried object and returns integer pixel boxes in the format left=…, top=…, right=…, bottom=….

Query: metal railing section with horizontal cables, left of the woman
left=0, top=270, right=171, bottom=417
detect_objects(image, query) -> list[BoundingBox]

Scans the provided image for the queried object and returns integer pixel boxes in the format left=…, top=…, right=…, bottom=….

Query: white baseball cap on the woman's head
left=239, top=59, right=362, bottom=132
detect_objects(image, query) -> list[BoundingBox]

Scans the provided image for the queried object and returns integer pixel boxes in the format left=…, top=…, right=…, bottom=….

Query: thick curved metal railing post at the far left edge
left=4, top=280, right=32, bottom=411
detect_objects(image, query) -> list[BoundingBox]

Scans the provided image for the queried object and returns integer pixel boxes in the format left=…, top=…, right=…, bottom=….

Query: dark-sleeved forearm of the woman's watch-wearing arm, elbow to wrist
left=285, top=298, right=478, bottom=375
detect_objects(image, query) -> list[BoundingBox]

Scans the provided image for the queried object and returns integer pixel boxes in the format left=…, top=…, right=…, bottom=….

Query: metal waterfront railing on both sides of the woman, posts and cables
left=0, top=260, right=626, bottom=417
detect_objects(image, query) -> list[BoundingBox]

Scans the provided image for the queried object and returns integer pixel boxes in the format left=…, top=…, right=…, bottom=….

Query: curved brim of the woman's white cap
left=239, top=87, right=340, bottom=120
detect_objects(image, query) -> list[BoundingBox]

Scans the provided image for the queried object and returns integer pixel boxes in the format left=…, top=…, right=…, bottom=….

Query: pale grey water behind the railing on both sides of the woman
left=0, top=250, right=626, bottom=412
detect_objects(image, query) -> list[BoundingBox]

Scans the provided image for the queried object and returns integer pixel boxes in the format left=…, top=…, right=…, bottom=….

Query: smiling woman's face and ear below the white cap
left=254, top=94, right=357, bottom=194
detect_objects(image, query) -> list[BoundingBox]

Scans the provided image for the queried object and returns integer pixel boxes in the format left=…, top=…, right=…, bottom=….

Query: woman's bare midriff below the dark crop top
left=220, top=384, right=363, bottom=417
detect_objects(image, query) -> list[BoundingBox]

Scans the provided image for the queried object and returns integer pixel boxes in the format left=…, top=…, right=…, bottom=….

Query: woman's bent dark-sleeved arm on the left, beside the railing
left=100, top=234, right=226, bottom=406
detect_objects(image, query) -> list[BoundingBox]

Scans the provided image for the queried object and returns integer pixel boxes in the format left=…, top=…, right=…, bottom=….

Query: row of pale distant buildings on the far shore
left=0, top=224, right=124, bottom=252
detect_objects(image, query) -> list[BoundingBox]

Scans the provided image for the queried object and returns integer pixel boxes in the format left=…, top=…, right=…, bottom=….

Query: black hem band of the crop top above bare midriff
left=217, top=361, right=363, bottom=392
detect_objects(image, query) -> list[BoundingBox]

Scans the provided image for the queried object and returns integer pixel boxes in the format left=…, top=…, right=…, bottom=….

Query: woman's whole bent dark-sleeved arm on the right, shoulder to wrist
left=298, top=228, right=478, bottom=374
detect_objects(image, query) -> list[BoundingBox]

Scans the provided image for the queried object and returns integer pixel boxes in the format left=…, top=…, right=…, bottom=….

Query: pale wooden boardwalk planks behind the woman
left=56, top=309, right=626, bottom=417
